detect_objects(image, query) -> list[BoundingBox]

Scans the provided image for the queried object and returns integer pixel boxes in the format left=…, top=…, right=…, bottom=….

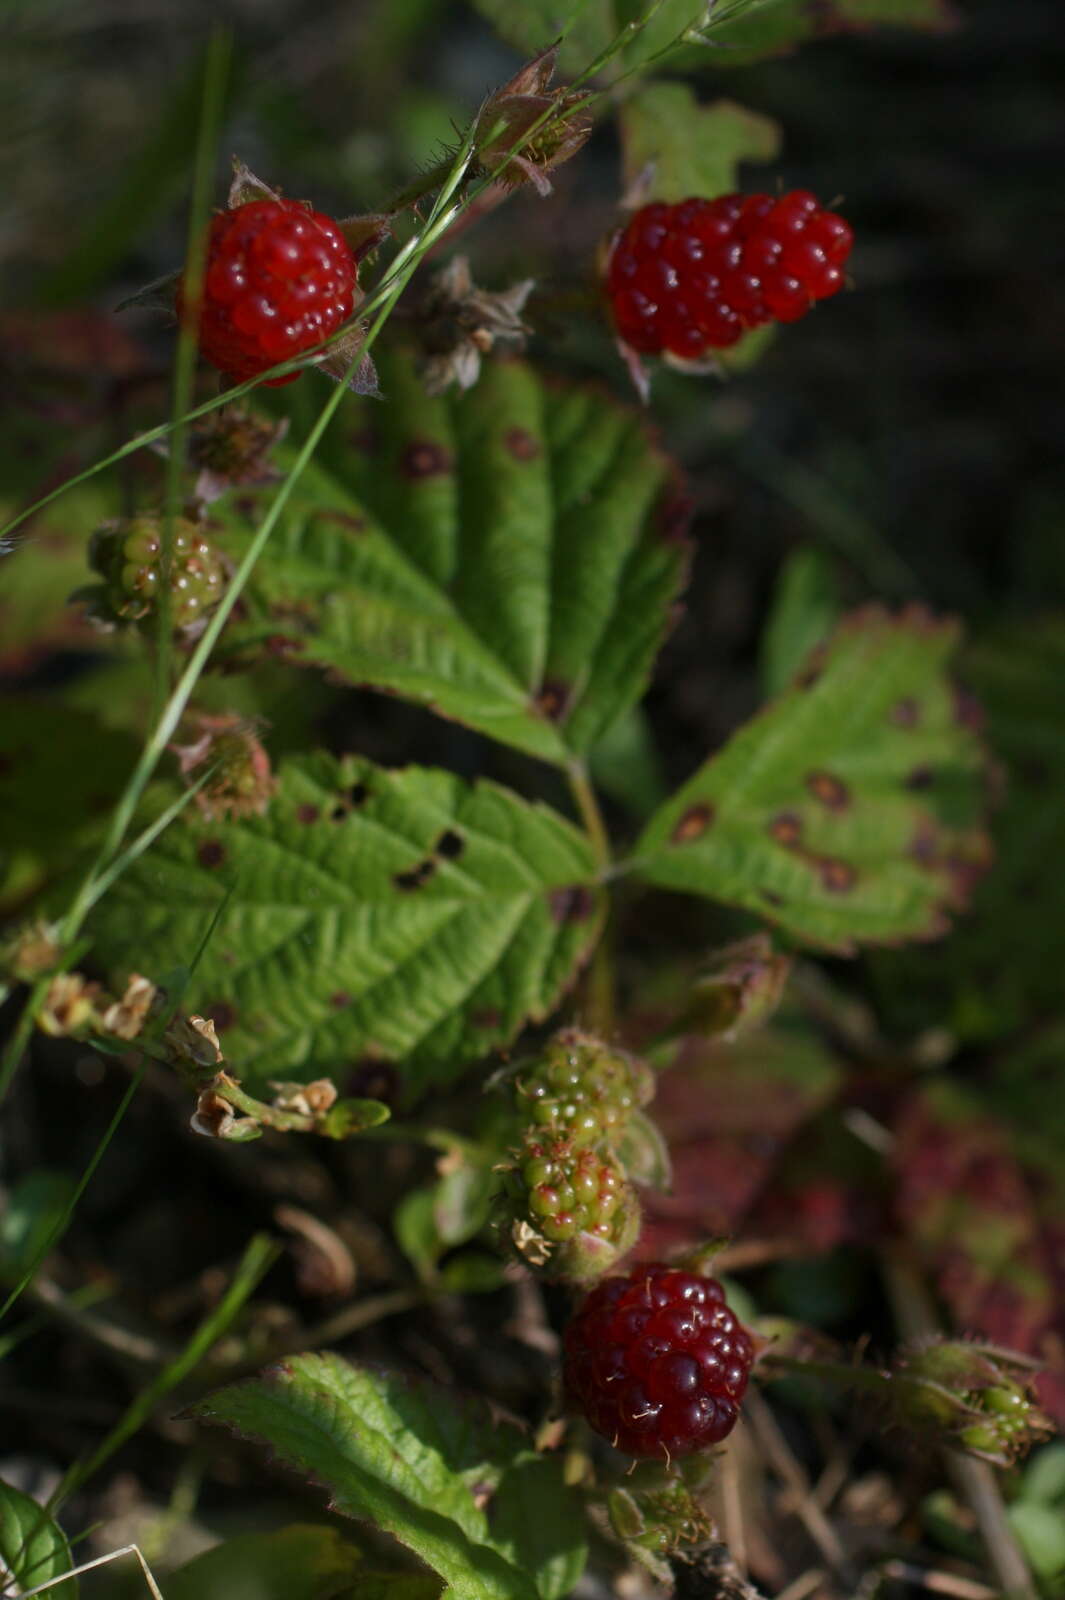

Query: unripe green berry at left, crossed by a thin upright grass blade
left=85, top=515, right=225, bottom=629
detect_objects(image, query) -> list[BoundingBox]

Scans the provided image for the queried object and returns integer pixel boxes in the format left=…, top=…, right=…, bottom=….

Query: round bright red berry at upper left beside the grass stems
left=176, top=200, right=358, bottom=386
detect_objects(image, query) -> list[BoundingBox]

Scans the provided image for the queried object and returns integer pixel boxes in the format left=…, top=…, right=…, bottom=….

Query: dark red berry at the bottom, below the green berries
left=563, top=1264, right=753, bottom=1459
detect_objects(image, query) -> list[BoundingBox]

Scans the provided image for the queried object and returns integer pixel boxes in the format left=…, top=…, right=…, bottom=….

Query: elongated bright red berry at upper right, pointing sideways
left=606, top=189, right=854, bottom=360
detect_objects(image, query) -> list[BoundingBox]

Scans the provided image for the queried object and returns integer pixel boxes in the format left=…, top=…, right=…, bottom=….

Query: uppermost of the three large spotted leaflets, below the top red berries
left=217, top=352, right=686, bottom=765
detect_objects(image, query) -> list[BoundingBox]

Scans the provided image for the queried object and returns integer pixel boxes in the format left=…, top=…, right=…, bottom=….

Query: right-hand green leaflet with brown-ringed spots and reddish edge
left=630, top=608, right=988, bottom=950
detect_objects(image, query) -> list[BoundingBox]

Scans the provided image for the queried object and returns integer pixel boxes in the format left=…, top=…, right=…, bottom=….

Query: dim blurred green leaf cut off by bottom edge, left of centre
left=166, top=1523, right=363, bottom=1600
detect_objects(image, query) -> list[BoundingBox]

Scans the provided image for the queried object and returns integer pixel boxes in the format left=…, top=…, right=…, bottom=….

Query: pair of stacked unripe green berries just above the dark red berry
left=505, top=1029, right=654, bottom=1283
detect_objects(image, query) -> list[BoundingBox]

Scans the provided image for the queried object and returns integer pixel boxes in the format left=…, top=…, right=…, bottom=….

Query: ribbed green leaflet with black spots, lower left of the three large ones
left=93, top=755, right=601, bottom=1091
